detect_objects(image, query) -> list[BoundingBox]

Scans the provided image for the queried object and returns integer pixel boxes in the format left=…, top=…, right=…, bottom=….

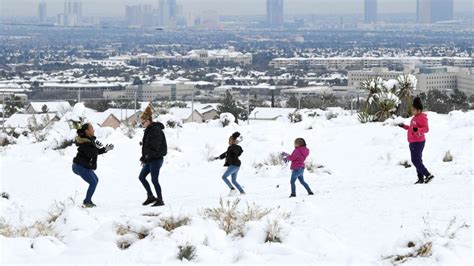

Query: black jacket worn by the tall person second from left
left=140, top=122, right=168, bottom=163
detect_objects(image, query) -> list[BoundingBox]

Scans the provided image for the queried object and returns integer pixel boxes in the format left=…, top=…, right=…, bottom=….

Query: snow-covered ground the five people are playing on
left=0, top=112, right=474, bottom=265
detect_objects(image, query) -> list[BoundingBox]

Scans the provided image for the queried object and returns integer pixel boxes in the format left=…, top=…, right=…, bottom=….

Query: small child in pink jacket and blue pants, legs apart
left=283, top=138, right=314, bottom=198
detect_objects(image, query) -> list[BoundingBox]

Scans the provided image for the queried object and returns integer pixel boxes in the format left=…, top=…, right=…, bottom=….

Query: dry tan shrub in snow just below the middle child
left=204, top=198, right=271, bottom=236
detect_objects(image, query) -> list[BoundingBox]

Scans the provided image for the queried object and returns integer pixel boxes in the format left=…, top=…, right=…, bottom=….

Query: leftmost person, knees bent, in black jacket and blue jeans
left=72, top=123, right=114, bottom=208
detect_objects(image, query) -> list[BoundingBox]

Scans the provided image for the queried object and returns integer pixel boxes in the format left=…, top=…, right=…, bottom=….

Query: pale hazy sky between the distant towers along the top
left=0, top=0, right=474, bottom=16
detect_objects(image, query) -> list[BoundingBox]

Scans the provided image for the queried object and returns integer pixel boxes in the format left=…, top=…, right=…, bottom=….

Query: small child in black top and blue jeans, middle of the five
left=215, top=132, right=245, bottom=195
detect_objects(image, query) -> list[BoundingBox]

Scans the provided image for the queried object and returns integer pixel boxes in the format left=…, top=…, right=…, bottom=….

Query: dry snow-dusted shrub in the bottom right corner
left=384, top=217, right=470, bottom=264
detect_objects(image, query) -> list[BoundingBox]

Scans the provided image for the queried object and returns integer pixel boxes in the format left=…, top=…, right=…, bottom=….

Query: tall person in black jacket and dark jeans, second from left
left=138, top=107, right=168, bottom=207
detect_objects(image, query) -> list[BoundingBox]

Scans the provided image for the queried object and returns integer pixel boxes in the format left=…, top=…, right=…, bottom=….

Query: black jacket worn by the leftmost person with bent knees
left=73, top=137, right=106, bottom=170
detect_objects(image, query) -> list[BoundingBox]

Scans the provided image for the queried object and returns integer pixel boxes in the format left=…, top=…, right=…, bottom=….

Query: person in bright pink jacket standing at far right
left=399, top=97, right=434, bottom=184
